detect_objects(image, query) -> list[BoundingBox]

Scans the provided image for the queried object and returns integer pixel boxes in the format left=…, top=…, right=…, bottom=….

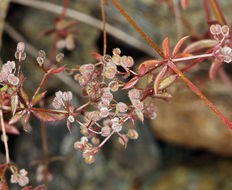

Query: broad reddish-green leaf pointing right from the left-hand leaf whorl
left=31, top=110, right=66, bottom=122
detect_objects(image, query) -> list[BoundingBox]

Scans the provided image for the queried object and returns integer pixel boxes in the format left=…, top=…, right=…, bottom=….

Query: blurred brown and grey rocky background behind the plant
left=0, top=0, right=232, bottom=190
